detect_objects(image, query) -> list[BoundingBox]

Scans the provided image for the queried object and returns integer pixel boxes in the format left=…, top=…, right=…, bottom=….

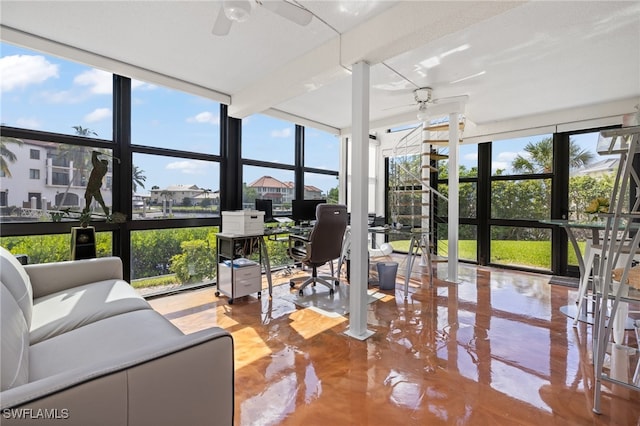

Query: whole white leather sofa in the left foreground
left=0, top=247, right=234, bottom=426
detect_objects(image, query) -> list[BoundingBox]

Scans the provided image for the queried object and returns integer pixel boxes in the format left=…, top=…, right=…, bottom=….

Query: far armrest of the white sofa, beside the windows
left=24, top=256, right=123, bottom=299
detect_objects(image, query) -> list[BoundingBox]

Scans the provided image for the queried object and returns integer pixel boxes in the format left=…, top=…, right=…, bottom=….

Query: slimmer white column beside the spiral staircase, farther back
left=447, top=112, right=460, bottom=282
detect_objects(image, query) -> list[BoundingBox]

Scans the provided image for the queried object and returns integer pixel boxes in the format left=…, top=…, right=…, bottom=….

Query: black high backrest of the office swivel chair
left=308, top=203, right=348, bottom=264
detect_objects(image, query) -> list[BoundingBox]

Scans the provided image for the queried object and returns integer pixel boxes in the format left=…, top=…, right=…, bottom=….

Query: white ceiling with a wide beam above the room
left=0, top=0, right=640, bottom=132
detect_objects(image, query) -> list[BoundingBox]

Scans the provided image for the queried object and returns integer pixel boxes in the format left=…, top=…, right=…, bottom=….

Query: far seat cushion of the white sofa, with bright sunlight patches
left=31, top=280, right=151, bottom=344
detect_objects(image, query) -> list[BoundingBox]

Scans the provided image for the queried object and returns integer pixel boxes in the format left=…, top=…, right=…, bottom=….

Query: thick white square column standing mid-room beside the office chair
left=346, top=62, right=373, bottom=340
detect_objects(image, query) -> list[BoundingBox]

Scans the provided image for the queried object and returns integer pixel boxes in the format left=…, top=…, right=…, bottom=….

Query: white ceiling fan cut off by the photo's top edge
left=211, top=0, right=313, bottom=36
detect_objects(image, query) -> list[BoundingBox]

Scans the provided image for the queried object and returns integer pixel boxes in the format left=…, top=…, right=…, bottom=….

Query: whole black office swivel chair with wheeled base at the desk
left=288, top=204, right=347, bottom=295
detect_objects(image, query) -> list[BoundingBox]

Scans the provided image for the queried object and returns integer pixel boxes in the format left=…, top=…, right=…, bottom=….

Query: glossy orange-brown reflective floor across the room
left=151, top=265, right=640, bottom=426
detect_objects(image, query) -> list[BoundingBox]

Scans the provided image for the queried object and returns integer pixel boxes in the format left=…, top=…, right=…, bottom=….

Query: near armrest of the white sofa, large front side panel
left=0, top=327, right=234, bottom=426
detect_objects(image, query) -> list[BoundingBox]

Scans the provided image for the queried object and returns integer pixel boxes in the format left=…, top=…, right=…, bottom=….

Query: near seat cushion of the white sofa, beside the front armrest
left=29, top=309, right=185, bottom=381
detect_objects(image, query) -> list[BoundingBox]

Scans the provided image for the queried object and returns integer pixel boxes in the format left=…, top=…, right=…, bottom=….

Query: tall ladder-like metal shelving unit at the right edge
left=593, top=126, right=640, bottom=414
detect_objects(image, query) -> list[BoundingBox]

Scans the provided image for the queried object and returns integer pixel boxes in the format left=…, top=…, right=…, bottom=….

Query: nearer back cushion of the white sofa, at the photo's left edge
left=0, top=283, right=29, bottom=391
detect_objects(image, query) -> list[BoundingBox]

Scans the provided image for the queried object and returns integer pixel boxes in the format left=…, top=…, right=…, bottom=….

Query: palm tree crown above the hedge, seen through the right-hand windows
left=511, top=137, right=593, bottom=173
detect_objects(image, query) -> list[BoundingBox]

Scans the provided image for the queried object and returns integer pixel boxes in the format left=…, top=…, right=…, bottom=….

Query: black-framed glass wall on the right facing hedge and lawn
left=389, top=129, right=617, bottom=274
